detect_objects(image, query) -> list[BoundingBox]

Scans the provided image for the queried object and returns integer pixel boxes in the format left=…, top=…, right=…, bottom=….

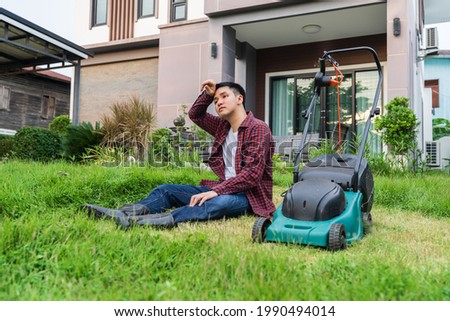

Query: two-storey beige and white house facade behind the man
left=72, top=0, right=431, bottom=155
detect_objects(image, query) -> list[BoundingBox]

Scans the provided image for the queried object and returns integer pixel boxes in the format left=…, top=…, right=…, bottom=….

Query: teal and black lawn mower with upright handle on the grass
left=252, top=47, right=383, bottom=251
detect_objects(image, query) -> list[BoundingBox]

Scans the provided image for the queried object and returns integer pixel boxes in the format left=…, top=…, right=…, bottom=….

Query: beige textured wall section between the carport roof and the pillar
left=80, top=58, right=158, bottom=123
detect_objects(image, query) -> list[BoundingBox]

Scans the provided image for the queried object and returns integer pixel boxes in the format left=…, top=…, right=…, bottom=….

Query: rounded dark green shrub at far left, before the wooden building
left=13, top=127, right=62, bottom=162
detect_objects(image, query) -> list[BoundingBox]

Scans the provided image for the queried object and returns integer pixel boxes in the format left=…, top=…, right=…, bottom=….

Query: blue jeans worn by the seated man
left=137, top=184, right=251, bottom=223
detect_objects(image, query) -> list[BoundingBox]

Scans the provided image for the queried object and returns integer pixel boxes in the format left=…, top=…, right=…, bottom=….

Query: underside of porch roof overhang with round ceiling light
left=230, top=1, right=387, bottom=49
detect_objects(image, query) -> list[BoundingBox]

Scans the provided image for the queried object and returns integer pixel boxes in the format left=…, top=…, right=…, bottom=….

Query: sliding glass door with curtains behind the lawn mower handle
left=270, top=70, right=381, bottom=153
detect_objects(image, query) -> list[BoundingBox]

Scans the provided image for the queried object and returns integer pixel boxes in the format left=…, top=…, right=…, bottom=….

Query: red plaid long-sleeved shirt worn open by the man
left=189, top=92, right=275, bottom=217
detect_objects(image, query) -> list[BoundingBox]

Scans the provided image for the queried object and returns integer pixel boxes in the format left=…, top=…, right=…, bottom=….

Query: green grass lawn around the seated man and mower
left=0, top=161, right=450, bottom=300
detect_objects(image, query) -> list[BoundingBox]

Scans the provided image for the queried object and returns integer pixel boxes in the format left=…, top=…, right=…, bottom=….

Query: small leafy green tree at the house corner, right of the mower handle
left=375, top=97, right=419, bottom=167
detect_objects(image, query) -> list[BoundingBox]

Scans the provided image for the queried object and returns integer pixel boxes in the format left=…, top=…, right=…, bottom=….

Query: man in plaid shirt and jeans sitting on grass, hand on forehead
left=81, top=80, right=275, bottom=228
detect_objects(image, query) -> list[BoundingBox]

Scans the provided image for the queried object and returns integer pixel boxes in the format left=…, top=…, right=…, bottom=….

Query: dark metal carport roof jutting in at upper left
left=0, top=8, right=94, bottom=75
